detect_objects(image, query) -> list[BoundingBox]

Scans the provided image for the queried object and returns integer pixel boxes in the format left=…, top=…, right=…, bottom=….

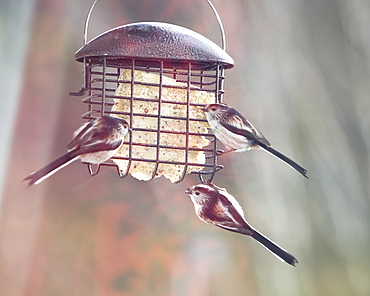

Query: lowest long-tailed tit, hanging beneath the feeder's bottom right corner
left=185, top=183, right=298, bottom=266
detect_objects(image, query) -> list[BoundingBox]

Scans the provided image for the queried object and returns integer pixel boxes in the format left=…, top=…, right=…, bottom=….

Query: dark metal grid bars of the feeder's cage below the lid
left=71, top=57, right=224, bottom=182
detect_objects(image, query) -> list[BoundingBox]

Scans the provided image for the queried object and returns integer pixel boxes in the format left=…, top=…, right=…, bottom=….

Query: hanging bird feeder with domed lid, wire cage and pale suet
left=71, top=4, right=234, bottom=183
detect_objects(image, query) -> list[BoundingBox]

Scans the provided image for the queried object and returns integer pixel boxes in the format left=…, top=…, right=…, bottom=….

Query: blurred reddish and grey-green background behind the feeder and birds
left=0, top=0, right=370, bottom=296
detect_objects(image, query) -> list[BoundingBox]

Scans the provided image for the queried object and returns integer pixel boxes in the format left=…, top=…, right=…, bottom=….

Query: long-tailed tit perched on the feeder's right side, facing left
left=204, top=104, right=308, bottom=179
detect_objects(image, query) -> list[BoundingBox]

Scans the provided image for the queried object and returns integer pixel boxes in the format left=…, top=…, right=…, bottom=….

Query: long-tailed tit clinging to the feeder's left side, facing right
left=23, top=116, right=129, bottom=186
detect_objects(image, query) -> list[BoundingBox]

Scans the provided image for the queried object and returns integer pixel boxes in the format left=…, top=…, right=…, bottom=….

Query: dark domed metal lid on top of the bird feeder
left=75, top=22, right=234, bottom=69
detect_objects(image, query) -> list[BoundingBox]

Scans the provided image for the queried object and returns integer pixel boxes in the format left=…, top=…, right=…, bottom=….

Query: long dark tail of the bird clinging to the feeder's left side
left=23, top=151, right=78, bottom=186
